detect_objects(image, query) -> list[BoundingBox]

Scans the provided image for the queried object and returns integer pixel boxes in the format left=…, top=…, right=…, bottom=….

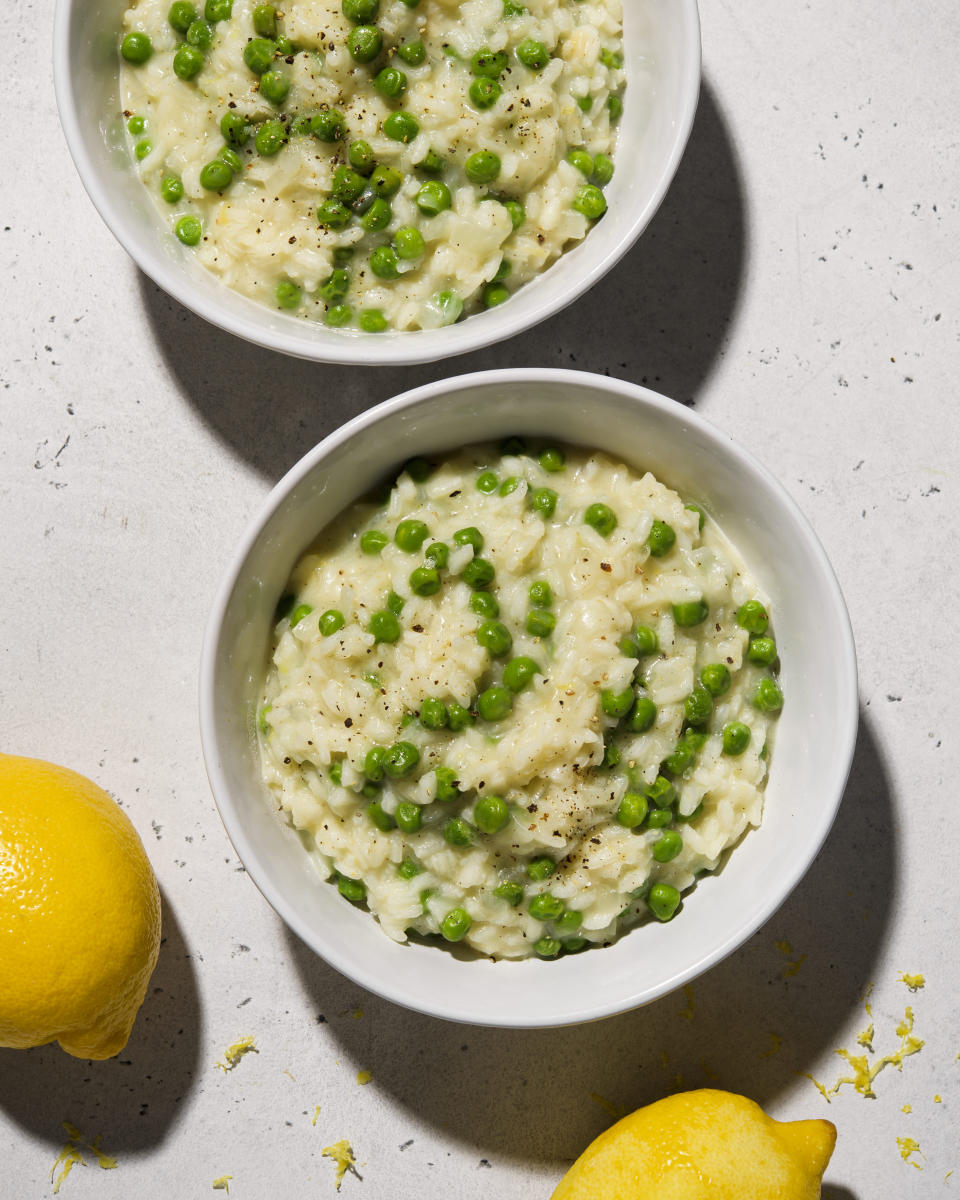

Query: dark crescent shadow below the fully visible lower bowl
left=287, top=712, right=898, bottom=1176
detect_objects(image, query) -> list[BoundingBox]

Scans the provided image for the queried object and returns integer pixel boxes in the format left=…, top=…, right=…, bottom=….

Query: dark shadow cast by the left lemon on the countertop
left=0, top=896, right=202, bottom=1154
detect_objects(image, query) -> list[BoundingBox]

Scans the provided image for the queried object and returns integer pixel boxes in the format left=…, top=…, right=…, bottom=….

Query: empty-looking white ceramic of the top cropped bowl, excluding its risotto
left=54, top=0, right=700, bottom=365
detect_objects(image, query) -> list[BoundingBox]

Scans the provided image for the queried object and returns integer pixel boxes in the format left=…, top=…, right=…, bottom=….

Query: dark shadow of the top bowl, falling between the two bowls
left=139, top=82, right=746, bottom=481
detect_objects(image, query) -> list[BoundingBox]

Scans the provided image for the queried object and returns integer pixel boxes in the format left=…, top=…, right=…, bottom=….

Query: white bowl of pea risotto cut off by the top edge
left=54, top=0, right=700, bottom=364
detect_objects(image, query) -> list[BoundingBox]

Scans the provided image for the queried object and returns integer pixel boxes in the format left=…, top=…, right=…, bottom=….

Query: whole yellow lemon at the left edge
left=0, top=754, right=160, bottom=1058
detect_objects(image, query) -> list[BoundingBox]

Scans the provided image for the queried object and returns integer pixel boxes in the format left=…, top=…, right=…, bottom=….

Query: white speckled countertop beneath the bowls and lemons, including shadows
left=0, top=0, right=960, bottom=1200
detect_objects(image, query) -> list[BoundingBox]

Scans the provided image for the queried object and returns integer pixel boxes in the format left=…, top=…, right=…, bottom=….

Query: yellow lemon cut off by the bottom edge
left=553, top=1088, right=836, bottom=1200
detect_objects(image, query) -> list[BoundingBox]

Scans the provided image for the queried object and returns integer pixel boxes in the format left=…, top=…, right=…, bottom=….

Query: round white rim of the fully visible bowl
left=198, top=367, right=859, bottom=1028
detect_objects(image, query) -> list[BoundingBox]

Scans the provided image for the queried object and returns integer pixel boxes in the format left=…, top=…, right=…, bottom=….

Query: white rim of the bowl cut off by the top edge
left=53, top=0, right=702, bottom=366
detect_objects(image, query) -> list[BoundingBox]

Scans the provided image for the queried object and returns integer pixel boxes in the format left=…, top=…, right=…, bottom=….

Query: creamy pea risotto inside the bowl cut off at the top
left=120, top=0, right=625, bottom=332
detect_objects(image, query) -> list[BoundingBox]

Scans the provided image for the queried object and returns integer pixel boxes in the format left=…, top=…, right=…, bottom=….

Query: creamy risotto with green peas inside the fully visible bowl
left=258, top=439, right=784, bottom=959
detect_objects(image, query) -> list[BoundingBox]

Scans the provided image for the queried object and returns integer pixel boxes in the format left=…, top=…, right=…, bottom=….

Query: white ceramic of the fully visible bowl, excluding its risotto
left=200, top=370, right=857, bottom=1026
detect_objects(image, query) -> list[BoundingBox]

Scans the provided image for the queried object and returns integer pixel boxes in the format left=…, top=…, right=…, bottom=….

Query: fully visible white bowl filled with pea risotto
left=200, top=371, right=857, bottom=1026
